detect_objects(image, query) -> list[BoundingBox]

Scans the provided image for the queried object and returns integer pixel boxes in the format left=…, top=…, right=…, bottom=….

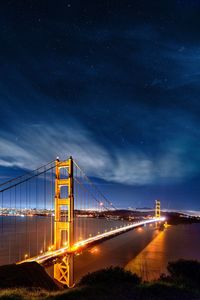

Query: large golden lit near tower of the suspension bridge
left=54, top=156, right=74, bottom=287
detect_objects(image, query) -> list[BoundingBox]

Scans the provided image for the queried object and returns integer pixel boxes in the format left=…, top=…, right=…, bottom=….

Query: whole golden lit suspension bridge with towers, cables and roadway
left=0, top=157, right=164, bottom=287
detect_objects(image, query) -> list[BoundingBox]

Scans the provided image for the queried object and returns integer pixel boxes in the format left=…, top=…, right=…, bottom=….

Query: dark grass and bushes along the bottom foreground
left=0, top=260, right=200, bottom=300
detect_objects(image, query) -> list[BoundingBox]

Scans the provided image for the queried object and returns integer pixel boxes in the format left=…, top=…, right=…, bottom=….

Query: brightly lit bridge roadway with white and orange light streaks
left=18, top=217, right=165, bottom=264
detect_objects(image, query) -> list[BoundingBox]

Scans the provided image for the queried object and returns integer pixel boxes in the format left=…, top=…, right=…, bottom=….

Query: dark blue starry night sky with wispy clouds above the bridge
left=0, top=0, right=200, bottom=210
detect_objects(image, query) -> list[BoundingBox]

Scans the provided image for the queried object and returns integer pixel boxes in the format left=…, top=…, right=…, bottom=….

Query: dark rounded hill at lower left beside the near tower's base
left=0, top=262, right=58, bottom=290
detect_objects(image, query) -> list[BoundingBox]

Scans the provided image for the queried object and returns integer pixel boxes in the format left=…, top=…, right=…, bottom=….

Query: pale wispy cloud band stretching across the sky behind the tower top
left=0, top=122, right=197, bottom=185
